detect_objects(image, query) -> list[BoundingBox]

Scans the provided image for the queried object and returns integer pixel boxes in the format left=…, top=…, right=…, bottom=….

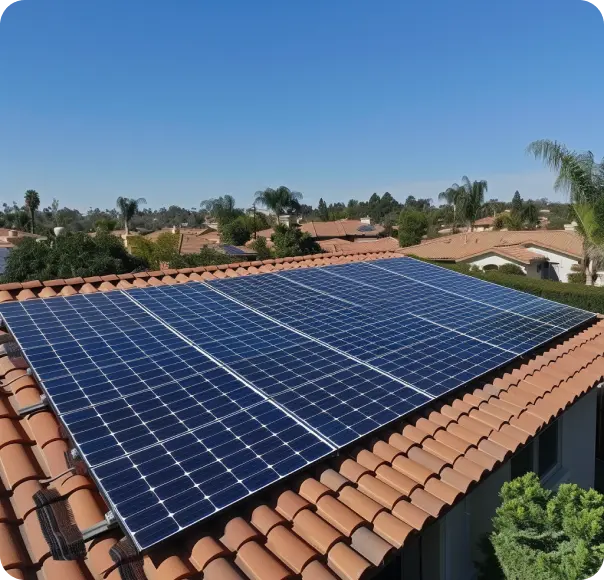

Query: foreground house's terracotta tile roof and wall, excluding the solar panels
left=0, top=244, right=604, bottom=580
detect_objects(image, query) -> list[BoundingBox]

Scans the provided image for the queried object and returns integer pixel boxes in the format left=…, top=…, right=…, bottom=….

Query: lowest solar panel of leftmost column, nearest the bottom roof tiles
left=95, top=401, right=333, bottom=549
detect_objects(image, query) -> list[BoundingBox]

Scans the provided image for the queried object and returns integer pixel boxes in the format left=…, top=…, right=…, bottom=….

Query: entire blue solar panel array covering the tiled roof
left=0, top=258, right=594, bottom=549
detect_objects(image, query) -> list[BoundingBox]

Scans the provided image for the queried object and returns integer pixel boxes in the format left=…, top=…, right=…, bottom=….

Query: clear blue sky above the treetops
left=0, top=0, right=604, bottom=209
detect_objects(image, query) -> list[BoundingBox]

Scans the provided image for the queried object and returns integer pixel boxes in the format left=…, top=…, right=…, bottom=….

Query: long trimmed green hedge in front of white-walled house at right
left=413, top=256, right=604, bottom=314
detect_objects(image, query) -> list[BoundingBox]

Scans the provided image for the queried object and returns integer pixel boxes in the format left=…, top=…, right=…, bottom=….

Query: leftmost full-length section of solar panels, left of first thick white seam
left=0, top=292, right=334, bottom=549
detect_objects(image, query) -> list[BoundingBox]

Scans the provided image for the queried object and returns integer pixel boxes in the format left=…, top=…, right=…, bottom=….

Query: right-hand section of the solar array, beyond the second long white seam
left=210, top=258, right=594, bottom=396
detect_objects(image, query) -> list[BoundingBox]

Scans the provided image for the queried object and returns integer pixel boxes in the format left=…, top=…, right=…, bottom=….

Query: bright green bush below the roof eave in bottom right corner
left=489, top=473, right=604, bottom=580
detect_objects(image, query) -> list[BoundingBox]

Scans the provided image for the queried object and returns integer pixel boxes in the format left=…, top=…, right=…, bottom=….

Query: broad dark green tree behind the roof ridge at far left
left=2, top=232, right=147, bottom=282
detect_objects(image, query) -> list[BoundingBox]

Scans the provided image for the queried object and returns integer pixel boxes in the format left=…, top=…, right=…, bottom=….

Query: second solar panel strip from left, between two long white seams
left=128, top=284, right=431, bottom=447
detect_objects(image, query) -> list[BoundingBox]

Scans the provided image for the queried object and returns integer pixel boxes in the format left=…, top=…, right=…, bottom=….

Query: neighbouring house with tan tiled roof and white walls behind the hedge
left=401, top=230, right=583, bottom=282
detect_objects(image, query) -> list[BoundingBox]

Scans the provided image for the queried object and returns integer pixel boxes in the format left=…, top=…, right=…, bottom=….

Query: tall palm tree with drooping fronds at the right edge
left=527, top=139, right=604, bottom=286
